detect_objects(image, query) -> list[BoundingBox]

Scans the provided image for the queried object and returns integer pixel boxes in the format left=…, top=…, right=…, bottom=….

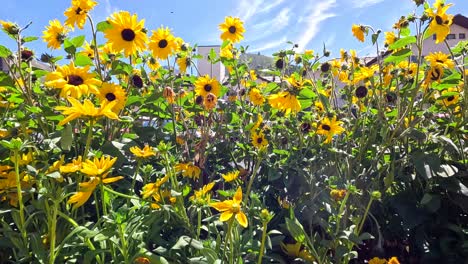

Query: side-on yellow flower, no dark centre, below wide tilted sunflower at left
left=55, top=97, right=119, bottom=126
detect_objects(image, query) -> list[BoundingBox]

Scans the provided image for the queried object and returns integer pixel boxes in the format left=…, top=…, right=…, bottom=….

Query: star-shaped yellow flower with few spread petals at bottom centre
left=210, top=186, right=248, bottom=227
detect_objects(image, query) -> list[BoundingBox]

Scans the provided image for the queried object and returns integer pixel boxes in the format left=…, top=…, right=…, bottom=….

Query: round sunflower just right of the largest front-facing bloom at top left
left=148, top=27, right=178, bottom=60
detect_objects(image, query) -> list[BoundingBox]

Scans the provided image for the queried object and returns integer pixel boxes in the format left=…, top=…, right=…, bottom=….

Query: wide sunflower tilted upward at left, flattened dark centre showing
left=45, top=62, right=101, bottom=98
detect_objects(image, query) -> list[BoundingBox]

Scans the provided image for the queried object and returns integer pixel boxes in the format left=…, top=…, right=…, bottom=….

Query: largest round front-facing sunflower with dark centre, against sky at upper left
left=104, top=11, right=148, bottom=57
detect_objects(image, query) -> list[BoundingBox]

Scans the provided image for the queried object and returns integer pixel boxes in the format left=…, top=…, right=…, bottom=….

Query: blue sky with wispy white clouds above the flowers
left=0, top=0, right=468, bottom=56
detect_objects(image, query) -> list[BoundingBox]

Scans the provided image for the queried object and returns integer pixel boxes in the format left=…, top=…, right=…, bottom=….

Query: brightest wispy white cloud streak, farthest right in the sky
left=297, top=0, right=336, bottom=51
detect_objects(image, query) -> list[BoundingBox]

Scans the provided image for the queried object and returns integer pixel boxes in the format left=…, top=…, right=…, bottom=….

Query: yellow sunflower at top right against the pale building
left=425, top=0, right=453, bottom=44
